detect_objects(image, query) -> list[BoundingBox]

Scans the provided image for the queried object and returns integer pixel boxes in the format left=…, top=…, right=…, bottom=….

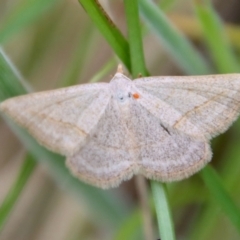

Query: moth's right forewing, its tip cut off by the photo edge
left=134, top=74, right=240, bottom=139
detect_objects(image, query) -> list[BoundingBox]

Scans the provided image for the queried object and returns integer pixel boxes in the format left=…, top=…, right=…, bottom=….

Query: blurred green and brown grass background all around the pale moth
left=0, top=0, right=240, bottom=240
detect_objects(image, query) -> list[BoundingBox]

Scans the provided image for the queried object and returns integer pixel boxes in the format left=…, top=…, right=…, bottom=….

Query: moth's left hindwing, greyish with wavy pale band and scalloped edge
left=67, top=100, right=138, bottom=188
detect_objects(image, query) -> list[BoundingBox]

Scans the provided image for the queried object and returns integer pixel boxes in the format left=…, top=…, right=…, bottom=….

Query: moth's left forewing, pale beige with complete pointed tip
left=0, top=83, right=110, bottom=155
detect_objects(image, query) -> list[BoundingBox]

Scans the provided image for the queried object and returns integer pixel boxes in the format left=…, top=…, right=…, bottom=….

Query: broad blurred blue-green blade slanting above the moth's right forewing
left=139, top=0, right=211, bottom=75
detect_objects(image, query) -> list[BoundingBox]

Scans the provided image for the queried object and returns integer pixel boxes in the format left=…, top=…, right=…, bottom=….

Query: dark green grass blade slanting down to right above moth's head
left=78, top=0, right=131, bottom=71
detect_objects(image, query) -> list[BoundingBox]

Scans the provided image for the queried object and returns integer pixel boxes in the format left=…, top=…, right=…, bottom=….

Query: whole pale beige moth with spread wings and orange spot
left=0, top=66, right=240, bottom=188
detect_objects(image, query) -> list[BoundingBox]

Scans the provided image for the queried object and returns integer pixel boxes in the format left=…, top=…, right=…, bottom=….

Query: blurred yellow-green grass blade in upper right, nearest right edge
left=195, top=1, right=240, bottom=73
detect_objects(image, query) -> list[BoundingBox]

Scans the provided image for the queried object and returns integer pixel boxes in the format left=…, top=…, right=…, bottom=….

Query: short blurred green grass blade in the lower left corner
left=0, top=155, right=36, bottom=232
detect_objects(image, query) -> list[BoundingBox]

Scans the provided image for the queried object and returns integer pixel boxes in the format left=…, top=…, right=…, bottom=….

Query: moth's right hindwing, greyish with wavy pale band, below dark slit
left=127, top=99, right=212, bottom=182
